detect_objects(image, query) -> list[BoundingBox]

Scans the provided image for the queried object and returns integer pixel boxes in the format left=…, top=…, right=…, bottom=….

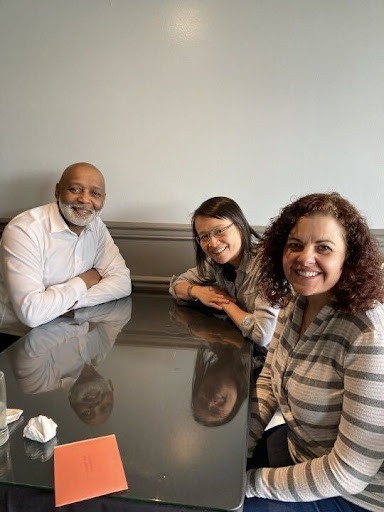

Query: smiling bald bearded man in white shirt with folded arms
left=0, top=162, right=131, bottom=327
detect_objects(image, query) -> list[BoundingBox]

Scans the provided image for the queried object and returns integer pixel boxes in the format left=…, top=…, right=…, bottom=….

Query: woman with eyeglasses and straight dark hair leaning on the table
left=169, top=197, right=278, bottom=347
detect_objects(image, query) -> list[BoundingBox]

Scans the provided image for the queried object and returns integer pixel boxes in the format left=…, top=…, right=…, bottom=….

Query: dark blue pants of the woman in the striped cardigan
left=243, top=425, right=366, bottom=512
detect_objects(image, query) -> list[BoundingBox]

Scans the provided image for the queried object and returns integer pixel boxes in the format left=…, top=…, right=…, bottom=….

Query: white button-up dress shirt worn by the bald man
left=0, top=203, right=131, bottom=327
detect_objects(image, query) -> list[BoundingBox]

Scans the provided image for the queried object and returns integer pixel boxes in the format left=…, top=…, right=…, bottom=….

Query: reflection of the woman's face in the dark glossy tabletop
left=194, top=373, right=237, bottom=423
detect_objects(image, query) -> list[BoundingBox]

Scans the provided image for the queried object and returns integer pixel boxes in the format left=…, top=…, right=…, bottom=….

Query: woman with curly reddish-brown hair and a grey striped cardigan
left=244, top=193, right=384, bottom=512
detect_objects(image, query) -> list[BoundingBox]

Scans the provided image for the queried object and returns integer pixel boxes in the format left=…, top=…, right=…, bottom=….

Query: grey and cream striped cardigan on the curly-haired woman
left=246, top=296, right=384, bottom=512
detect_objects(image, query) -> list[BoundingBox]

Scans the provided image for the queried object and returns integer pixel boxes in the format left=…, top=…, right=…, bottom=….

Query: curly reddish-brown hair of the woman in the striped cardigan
left=259, top=192, right=384, bottom=313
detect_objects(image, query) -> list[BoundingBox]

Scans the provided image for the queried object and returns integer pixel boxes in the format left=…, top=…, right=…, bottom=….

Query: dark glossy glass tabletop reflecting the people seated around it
left=0, top=292, right=251, bottom=510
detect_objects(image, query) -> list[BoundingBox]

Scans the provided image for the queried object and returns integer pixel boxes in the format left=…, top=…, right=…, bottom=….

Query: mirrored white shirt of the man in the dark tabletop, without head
left=9, top=297, right=132, bottom=394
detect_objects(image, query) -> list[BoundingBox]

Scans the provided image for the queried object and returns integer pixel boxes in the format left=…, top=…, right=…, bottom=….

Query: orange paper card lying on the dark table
left=54, top=435, right=128, bottom=507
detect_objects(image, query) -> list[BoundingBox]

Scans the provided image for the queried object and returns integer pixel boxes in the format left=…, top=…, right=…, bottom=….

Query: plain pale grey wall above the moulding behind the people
left=0, top=0, right=384, bottom=228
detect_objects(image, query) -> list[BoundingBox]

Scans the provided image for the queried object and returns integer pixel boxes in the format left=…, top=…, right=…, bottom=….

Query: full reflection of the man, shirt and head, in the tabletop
left=7, top=297, right=132, bottom=425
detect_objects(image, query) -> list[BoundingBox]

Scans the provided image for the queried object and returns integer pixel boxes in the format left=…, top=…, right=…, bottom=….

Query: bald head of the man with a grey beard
left=55, top=162, right=105, bottom=235
